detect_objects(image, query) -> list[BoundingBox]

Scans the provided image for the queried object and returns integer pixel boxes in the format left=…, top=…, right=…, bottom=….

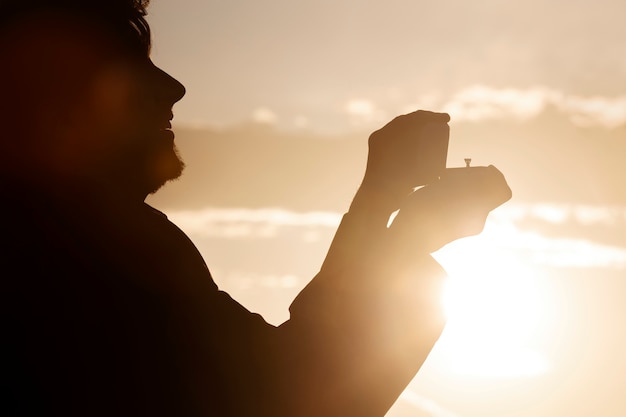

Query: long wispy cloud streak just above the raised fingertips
left=172, top=84, right=626, bottom=132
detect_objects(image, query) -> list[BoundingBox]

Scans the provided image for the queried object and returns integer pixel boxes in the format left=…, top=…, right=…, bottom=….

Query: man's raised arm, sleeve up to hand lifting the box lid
left=281, top=111, right=449, bottom=416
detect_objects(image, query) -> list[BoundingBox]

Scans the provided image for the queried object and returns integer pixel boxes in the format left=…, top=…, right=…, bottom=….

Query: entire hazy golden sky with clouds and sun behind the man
left=143, top=0, right=626, bottom=417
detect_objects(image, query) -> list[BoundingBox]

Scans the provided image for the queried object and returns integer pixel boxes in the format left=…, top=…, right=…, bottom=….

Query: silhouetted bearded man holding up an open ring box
left=0, top=0, right=506, bottom=417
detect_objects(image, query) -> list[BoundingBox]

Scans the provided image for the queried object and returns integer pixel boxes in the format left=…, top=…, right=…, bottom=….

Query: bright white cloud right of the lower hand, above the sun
left=437, top=204, right=626, bottom=269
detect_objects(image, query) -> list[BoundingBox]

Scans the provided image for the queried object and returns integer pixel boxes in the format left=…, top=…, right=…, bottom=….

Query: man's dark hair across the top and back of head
left=0, top=0, right=151, bottom=177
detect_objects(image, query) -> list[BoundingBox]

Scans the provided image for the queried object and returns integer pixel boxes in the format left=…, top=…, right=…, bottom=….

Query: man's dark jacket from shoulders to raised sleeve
left=0, top=184, right=443, bottom=417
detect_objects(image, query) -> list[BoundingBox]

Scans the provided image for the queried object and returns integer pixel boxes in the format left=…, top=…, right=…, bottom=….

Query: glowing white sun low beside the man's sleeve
left=434, top=219, right=554, bottom=378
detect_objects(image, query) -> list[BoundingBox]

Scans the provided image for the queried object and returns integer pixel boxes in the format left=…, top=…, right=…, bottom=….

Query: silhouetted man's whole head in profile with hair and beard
left=0, top=0, right=185, bottom=196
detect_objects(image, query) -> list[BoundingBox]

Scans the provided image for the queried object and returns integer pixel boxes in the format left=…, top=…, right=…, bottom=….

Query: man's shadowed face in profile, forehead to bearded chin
left=91, top=53, right=185, bottom=194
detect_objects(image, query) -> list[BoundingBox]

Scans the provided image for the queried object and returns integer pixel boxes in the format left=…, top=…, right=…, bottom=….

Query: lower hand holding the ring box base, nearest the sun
left=389, top=166, right=511, bottom=252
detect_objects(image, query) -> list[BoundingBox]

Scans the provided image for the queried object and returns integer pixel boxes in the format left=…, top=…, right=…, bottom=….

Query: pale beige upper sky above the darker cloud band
left=149, top=0, right=626, bottom=131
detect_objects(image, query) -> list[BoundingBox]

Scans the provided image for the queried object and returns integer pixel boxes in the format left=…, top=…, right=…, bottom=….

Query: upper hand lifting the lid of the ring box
left=359, top=110, right=450, bottom=211
